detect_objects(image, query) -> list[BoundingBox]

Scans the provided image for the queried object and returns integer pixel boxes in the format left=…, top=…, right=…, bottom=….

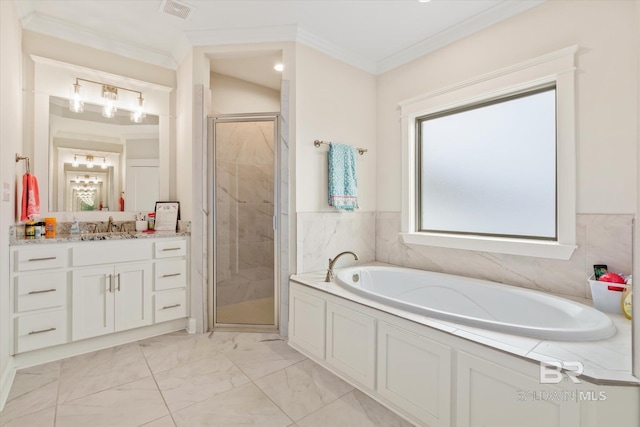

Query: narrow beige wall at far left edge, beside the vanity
left=0, top=1, right=24, bottom=409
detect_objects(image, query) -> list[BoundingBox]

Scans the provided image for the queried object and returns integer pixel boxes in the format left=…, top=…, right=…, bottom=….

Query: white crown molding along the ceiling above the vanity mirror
left=22, top=12, right=178, bottom=69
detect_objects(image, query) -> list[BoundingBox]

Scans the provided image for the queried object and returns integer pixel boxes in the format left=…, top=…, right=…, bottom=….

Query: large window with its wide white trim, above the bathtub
left=400, top=46, right=577, bottom=260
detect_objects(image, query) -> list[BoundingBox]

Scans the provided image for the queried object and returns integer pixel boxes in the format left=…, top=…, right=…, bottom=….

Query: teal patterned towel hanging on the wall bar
left=329, top=143, right=358, bottom=211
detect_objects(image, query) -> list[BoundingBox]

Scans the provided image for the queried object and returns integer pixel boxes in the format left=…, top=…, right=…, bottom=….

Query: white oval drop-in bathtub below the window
left=336, top=266, right=616, bottom=341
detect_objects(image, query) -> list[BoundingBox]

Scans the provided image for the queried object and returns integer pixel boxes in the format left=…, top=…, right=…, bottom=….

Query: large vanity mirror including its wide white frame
left=31, top=55, right=175, bottom=221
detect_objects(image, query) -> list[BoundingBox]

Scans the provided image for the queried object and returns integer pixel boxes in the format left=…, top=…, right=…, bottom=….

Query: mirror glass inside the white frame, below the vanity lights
left=49, top=96, right=160, bottom=212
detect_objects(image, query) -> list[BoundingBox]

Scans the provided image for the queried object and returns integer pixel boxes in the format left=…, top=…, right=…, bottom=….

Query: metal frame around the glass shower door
left=206, top=112, right=282, bottom=332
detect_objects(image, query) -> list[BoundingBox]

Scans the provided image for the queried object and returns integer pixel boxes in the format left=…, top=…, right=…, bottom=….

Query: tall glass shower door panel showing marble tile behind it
left=214, top=117, right=276, bottom=326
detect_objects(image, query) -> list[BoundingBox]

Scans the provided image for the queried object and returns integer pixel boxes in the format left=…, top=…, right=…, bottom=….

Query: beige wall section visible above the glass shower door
left=211, top=73, right=280, bottom=114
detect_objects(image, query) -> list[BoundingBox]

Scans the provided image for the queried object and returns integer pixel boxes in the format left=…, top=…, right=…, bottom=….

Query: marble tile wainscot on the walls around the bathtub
left=297, top=212, right=633, bottom=298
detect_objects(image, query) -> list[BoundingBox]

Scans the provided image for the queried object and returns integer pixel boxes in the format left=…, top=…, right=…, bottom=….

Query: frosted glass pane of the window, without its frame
left=418, top=88, right=556, bottom=240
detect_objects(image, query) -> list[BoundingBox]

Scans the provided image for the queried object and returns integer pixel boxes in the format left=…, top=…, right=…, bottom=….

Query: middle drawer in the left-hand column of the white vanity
left=15, top=271, right=67, bottom=312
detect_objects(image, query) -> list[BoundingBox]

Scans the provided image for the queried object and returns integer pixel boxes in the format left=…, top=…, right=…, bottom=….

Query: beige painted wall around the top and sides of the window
left=377, top=1, right=638, bottom=214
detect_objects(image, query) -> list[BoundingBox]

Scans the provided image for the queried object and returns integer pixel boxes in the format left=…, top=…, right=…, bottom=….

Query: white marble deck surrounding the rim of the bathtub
left=291, top=262, right=640, bottom=385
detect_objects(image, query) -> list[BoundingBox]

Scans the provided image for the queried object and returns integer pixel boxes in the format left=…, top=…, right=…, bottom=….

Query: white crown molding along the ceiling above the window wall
left=375, top=0, right=546, bottom=74
